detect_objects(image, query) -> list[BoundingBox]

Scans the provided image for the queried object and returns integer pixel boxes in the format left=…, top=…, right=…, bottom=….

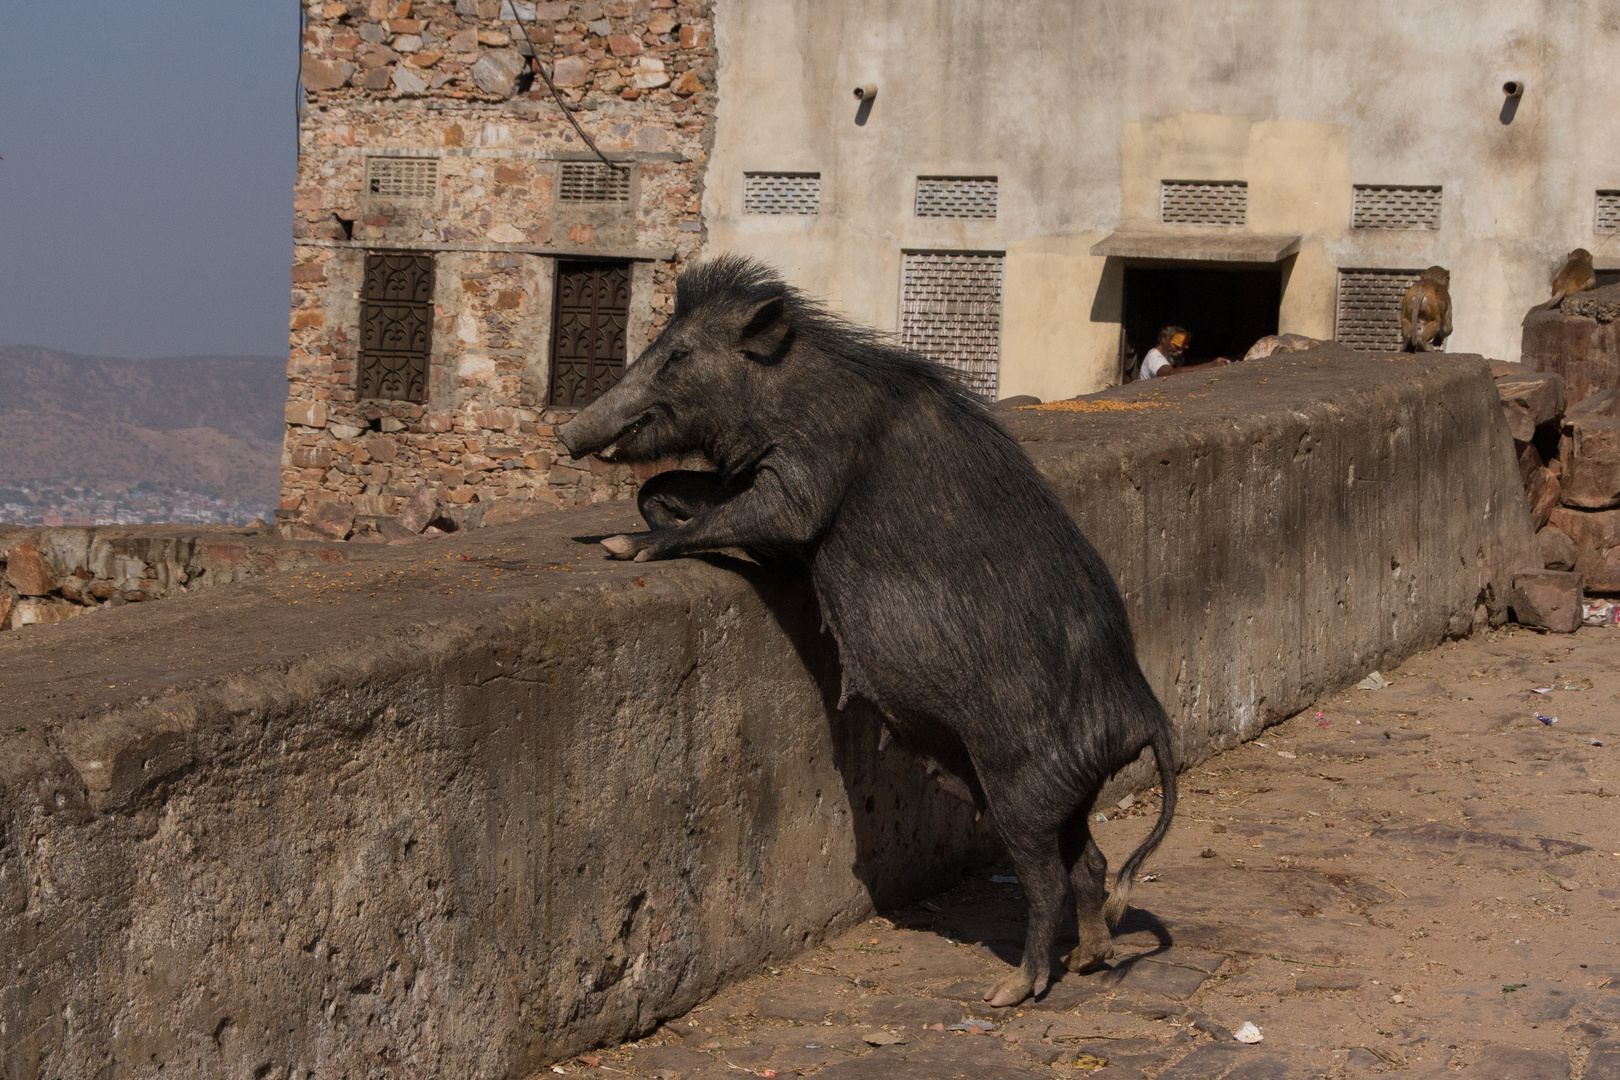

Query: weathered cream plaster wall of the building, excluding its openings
left=705, top=0, right=1620, bottom=398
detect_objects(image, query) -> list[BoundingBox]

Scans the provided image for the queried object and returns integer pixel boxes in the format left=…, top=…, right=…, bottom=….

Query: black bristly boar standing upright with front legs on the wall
left=559, top=256, right=1176, bottom=1004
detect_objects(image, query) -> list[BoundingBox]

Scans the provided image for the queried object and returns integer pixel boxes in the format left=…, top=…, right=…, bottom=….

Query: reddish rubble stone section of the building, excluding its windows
left=279, top=0, right=714, bottom=539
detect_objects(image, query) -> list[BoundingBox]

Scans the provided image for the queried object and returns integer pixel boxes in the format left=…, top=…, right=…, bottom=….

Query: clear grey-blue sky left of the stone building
left=0, top=0, right=298, bottom=356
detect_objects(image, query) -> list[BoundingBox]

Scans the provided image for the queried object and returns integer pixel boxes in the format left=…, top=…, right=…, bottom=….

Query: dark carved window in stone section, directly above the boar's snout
left=551, top=262, right=630, bottom=408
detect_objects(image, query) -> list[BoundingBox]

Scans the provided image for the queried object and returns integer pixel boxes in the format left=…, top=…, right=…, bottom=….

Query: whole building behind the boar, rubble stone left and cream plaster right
left=284, top=0, right=1620, bottom=527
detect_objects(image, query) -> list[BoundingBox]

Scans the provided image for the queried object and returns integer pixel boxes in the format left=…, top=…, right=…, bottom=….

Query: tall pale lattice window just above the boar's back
left=901, top=251, right=1003, bottom=402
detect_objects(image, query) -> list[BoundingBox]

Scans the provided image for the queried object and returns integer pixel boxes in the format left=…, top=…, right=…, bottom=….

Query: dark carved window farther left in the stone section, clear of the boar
left=360, top=251, right=433, bottom=402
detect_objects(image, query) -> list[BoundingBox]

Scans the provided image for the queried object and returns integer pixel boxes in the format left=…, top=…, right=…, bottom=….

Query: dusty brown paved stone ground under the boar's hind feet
left=546, top=630, right=1620, bottom=1080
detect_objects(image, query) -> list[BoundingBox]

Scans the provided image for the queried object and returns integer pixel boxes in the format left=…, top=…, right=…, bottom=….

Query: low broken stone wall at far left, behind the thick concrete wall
left=0, top=526, right=343, bottom=630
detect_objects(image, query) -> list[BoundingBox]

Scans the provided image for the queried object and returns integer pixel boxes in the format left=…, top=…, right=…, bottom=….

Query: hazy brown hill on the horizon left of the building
left=0, top=345, right=287, bottom=505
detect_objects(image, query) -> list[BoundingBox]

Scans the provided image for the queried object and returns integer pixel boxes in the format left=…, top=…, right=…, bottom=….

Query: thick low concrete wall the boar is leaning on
left=0, top=355, right=1536, bottom=1080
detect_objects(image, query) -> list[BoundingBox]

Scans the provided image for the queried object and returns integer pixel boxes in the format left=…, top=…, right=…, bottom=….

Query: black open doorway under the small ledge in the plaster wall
left=1121, top=266, right=1283, bottom=372
